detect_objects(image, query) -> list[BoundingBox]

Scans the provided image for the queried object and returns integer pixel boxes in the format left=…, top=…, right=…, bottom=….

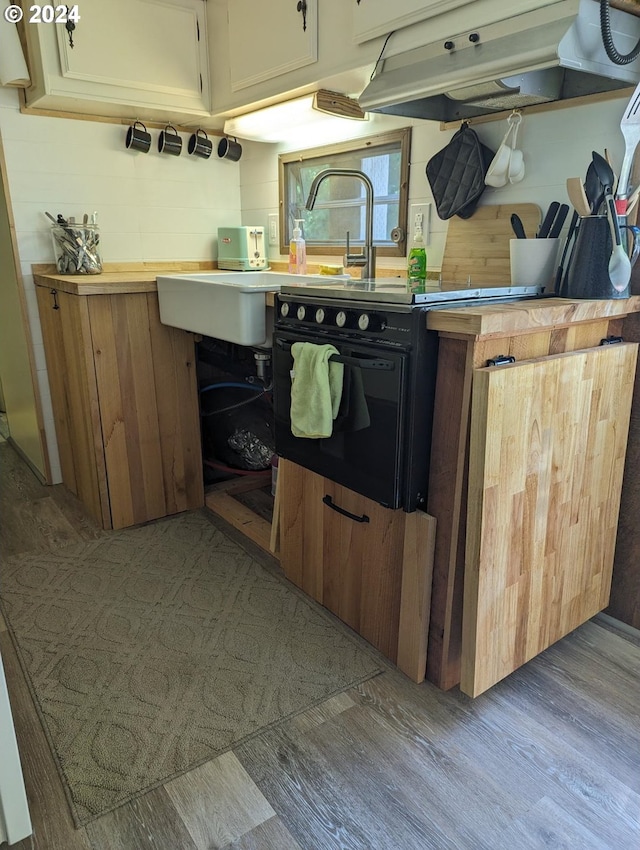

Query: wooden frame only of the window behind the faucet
left=278, top=127, right=411, bottom=257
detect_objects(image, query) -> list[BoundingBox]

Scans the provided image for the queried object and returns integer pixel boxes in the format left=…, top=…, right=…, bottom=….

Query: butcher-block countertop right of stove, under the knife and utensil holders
left=427, top=295, right=640, bottom=336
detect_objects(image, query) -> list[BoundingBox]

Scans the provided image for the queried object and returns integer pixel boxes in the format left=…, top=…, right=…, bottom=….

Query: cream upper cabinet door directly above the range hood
left=352, top=0, right=474, bottom=44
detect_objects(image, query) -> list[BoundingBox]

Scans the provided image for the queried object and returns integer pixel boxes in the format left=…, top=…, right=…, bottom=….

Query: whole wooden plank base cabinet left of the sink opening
left=36, top=285, right=204, bottom=528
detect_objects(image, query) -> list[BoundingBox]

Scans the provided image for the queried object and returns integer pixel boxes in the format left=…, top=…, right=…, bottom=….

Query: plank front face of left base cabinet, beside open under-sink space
left=86, top=293, right=204, bottom=528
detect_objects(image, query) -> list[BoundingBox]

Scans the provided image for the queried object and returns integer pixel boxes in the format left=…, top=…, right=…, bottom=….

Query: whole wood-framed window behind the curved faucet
left=278, top=129, right=411, bottom=256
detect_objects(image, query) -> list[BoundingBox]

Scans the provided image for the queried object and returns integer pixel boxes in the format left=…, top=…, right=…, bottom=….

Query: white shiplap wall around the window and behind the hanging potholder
left=240, top=96, right=627, bottom=269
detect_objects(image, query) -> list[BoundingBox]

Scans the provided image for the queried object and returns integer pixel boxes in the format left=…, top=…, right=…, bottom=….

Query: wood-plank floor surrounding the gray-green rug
left=0, top=444, right=640, bottom=850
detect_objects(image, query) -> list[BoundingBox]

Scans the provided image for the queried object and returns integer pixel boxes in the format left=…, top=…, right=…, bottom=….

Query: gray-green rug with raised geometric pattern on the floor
left=0, top=512, right=382, bottom=825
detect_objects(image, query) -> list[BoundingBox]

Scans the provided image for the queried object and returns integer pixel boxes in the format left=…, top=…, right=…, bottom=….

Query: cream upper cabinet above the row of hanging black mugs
left=25, top=0, right=211, bottom=120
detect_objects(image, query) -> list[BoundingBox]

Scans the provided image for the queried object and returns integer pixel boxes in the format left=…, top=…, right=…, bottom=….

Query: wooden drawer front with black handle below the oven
left=278, top=460, right=435, bottom=682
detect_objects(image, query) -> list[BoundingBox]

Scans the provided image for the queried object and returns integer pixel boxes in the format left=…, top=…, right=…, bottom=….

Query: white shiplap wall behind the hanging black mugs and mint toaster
left=0, top=88, right=240, bottom=483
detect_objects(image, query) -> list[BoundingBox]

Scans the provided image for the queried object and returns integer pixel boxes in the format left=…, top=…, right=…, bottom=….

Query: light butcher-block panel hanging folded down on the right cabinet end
left=460, top=343, right=638, bottom=696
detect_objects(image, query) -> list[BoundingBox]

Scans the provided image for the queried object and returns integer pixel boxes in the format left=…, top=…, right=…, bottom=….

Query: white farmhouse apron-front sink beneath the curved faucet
left=157, top=272, right=344, bottom=345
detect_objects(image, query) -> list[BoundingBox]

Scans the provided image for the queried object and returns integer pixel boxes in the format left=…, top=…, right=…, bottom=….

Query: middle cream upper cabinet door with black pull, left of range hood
left=228, top=0, right=318, bottom=91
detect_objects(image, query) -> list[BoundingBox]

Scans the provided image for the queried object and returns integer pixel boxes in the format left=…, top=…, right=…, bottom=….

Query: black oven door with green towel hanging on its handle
left=273, top=331, right=408, bottom=508
